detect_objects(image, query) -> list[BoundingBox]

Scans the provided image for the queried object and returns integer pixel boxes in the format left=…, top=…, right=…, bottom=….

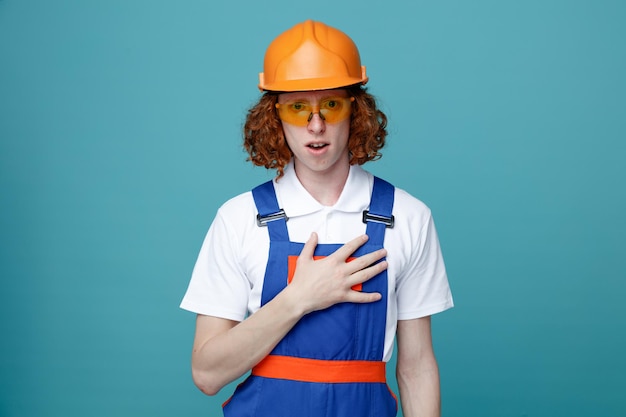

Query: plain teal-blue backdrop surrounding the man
left=0, top=0, right=626, bottom=417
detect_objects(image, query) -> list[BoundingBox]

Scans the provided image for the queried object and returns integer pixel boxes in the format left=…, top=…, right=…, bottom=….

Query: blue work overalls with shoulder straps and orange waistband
left=224, top=177, right=397, bottom=417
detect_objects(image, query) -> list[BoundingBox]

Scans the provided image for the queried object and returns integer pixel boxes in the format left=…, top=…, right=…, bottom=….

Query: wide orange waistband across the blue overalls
left=252, top=355, right=387, bottom=383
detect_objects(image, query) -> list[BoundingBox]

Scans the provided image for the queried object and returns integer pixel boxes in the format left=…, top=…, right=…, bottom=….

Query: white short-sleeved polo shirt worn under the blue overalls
left=181, top=163, right=453, bottom=361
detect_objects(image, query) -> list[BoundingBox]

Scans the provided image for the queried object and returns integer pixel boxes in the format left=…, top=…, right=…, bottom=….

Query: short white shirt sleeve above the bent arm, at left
left=180, top=209, right=250, bottom=321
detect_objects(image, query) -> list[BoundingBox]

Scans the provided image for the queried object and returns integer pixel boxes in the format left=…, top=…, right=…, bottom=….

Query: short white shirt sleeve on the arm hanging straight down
left=396, top=211, right=454, bottom=320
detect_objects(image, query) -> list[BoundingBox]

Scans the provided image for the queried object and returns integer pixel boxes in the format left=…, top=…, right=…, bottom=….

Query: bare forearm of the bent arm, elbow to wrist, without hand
left=192, top=291, right=303, bottom=395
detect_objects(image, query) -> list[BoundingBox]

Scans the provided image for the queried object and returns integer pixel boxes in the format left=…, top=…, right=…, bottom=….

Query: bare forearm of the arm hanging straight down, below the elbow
left=397, top=358, right=441, bottom=417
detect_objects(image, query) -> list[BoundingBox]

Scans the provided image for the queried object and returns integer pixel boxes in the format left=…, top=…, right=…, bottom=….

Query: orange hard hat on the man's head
left=259, top=20, right=368, bottom=92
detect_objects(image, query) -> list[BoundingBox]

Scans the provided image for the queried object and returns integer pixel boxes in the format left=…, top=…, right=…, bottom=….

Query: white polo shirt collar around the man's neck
left=274, top=160, right=373, bottom=217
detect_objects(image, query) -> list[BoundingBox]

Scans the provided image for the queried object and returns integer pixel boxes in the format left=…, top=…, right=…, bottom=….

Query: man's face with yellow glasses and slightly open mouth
left=278, top=90, right=351, bottom=180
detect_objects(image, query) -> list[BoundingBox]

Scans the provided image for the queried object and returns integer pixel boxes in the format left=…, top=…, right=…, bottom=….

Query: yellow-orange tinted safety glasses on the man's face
left=276, top=97, right=354, bottom=126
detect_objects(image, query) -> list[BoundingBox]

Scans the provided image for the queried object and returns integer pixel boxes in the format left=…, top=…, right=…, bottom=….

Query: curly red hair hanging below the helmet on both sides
left=243, top=85, right=387, bottom=178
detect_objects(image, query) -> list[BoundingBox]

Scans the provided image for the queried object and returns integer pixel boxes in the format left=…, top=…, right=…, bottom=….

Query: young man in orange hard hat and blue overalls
left=181, top=21, right=453, bottom=417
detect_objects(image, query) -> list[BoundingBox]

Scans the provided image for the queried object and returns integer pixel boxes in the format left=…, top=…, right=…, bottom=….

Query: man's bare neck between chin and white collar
left=295, top=163, right=350, bottom=206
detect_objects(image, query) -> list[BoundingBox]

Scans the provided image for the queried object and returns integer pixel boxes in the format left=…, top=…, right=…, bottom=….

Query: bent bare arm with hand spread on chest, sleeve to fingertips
left=192, top=233, right=387, bottom=395
